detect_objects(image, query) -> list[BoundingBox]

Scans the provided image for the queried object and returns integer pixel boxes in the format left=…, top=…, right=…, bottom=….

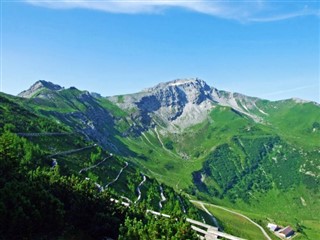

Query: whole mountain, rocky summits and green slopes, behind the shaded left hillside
left=5, top=79, right=320, bottom=239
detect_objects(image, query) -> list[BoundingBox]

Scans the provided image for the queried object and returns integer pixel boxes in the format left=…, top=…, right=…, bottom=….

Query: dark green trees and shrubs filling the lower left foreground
left=0, top=129, right=197, bottom=239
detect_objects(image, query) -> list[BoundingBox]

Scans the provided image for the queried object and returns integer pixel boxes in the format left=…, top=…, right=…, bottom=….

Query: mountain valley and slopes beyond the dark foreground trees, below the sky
left=0, top=79, right=320, bottom=239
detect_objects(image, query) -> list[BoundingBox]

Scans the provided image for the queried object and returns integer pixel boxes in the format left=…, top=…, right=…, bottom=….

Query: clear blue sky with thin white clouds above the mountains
left=1, top=0, right=320, bottom=102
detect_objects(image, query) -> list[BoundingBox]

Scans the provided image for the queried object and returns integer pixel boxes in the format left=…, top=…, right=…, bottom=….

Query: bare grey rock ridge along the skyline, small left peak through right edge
left=18, top=78, right=318, bottom=139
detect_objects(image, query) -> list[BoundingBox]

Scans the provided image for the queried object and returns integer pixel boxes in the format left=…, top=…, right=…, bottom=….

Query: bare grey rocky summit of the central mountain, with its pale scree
left=108, top=79, right=270, bottom=132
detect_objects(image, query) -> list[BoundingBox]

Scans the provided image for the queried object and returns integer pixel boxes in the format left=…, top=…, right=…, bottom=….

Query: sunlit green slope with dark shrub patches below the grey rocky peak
left=119, top=103, right=320, bottom=239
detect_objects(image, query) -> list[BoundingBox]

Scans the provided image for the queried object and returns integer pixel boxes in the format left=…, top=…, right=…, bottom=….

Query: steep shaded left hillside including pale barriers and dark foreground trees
left=0, top=94, right=205, bottom=239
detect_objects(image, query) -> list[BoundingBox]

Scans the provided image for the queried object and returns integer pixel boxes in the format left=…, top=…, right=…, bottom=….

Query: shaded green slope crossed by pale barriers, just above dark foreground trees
left=0, top=92, right=201, bottom=218
